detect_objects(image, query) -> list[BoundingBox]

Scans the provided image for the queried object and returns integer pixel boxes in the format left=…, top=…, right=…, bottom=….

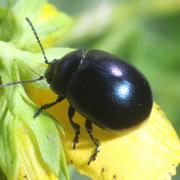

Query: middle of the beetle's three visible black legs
left=68, top=106, right=80, bottom=149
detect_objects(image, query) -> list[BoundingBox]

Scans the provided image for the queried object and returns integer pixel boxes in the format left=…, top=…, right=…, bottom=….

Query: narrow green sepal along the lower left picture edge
left=0, top=96, right=18, bottom=180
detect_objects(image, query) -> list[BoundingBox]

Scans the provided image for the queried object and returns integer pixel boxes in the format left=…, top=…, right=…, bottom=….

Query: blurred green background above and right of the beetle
left=47, top=0, right=180, bottom=180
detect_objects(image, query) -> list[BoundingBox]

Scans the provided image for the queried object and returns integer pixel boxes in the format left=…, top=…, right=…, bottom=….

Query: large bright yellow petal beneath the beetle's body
left=27, top=85, right=180, bottom=180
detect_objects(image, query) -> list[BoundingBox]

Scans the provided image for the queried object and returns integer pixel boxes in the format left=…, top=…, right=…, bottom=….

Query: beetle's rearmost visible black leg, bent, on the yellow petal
left=85, top=119, right=100, bottom=165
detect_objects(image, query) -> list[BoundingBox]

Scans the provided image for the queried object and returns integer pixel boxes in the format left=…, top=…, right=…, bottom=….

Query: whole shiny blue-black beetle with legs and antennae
left=0, top=18, right=153, bottom=165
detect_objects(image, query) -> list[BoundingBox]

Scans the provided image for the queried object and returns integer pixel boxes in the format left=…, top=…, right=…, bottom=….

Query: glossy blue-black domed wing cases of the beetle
left=66, top=50, right=152, bottom=130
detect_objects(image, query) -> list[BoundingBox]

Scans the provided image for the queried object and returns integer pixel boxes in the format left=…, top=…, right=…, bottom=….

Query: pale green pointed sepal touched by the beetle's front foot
left=2, top=56, right=60, bottom=175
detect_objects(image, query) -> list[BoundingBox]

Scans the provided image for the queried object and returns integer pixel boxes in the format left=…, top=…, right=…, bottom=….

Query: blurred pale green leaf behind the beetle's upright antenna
left=12, top=0, right=72, bottom=51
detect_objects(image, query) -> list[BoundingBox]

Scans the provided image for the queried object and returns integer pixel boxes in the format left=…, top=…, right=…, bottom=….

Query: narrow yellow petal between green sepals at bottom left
left=17, top=119, right=58, bottom=180
